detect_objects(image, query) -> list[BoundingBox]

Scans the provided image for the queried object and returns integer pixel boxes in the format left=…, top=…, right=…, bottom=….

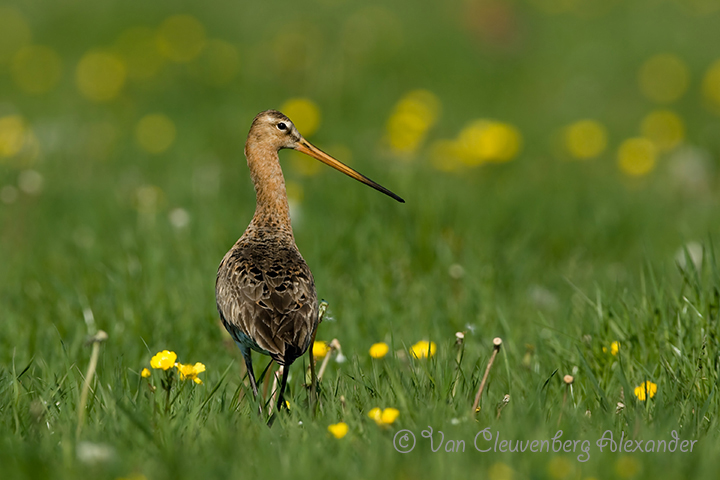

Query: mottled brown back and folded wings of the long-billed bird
left=215, top=234, right=318, bottom=365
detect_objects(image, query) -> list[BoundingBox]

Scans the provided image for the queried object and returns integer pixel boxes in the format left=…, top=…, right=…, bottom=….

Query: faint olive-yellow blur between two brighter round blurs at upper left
left=115, top=27, right=166, bottom=80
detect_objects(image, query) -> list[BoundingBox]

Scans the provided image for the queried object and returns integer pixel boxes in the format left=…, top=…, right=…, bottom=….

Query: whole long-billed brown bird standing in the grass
left=215, top=110, right=403, bottom=408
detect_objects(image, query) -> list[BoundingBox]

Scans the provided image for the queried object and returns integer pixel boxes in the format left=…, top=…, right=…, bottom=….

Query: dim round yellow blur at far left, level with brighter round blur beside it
left=10, top=45, right=62, bottom=94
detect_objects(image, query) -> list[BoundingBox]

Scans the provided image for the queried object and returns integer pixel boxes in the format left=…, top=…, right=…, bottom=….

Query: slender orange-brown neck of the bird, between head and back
left=245, top=142, right=292, bottom=237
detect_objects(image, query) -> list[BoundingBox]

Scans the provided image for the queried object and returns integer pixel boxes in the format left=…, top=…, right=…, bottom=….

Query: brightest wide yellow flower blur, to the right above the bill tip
left=458, top=119, right=522, bottom=166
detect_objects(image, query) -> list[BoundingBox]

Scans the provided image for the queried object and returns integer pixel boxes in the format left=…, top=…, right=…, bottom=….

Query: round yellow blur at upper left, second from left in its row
left=75, top=51, right=126, bottom=102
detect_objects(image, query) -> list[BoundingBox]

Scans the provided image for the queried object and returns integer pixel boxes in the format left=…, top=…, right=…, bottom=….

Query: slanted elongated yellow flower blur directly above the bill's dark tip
left=386, top=90, right=440, bottom=155
